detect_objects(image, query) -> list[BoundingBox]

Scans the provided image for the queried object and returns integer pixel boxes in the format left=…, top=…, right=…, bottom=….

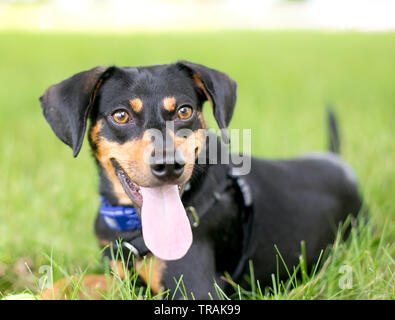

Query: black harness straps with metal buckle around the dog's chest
left=103, top=170, right=254, bottom=282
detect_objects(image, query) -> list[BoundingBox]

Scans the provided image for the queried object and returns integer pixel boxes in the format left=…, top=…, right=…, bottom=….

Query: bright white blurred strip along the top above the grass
left=0, top=0, right=395, bottom=32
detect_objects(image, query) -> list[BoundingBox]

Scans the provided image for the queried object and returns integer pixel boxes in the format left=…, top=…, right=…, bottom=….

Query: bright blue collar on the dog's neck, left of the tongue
left=99, top=196, right=141, bottom=231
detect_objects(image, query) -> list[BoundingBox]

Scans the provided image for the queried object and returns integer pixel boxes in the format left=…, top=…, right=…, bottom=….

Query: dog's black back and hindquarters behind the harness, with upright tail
left=234, top=110, right=362, bottom=280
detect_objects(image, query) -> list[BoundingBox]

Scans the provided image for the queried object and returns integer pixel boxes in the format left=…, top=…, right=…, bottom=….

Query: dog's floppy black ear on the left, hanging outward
left=40, top=67, right=113, bottom=157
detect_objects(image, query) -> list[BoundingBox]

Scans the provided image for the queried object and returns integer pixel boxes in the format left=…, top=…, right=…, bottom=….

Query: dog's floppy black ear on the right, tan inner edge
left=177, top=61, right=237, bottom=142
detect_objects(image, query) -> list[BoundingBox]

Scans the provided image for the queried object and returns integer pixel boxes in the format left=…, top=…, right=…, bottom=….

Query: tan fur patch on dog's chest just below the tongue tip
left=135, top=256, right=166, bottom=294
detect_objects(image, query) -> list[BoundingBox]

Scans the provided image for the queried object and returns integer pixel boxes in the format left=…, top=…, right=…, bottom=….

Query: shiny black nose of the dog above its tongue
left=150, top=151, right=185, bottom=181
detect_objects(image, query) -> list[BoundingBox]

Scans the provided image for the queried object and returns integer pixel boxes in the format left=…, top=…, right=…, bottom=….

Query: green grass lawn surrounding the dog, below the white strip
left=0, top=32, right=395, bottom=299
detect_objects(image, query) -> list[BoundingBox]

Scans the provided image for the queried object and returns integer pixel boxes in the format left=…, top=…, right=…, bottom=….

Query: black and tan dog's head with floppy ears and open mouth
left=40, top=61, right=236, bottom=255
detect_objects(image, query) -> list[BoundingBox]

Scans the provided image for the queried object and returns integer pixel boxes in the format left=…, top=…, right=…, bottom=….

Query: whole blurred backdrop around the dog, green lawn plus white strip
left=0, top=0, right=395, bottom=299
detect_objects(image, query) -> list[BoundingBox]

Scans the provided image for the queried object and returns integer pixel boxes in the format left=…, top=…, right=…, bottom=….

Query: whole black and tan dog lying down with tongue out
left=40, top=61, right=361, bottom=299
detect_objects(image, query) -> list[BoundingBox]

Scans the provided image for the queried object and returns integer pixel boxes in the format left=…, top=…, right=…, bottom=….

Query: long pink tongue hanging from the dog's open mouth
left=141, top=185, right=192, bottom=260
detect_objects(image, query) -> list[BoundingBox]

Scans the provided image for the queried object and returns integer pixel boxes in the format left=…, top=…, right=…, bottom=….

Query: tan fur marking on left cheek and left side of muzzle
left=90, top=120, right=152, bottom=205
